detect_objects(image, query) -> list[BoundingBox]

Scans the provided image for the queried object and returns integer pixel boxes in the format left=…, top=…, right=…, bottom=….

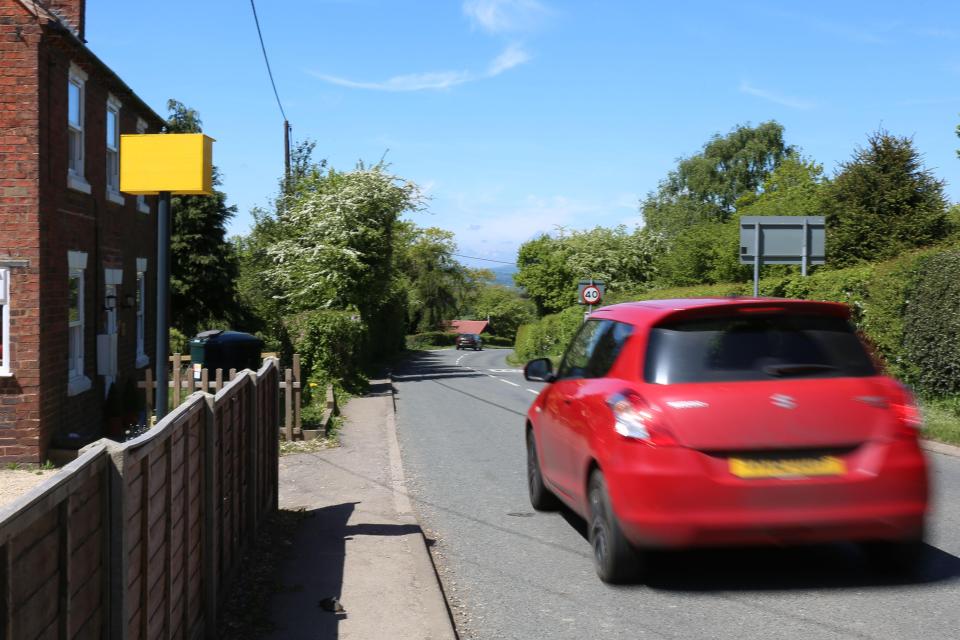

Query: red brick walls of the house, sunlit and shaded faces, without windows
left=0, top=0, right=157, bottom=462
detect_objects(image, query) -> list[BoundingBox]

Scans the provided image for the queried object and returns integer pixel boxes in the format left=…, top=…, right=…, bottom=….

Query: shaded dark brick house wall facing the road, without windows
left=40, top=33, right=156, bottom=456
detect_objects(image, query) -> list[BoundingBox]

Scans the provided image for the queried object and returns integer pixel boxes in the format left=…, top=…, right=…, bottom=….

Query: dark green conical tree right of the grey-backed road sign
left=821, top=130, right=948, bottom=267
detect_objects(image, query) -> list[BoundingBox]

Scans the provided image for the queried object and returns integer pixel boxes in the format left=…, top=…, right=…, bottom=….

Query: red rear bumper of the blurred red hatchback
left=604, top=441, right=928, bottom=547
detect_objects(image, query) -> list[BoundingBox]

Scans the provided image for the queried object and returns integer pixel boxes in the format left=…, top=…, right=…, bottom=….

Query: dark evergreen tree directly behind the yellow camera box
left=166, top=100, right=243, bottom=336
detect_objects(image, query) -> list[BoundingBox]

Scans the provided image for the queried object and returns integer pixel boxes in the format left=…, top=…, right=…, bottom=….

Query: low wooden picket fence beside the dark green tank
left=137, top=353, right=339, bottom=441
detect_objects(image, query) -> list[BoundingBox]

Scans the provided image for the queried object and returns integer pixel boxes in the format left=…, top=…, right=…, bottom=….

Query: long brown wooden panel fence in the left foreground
left=0, top=359, right=280, bottom=640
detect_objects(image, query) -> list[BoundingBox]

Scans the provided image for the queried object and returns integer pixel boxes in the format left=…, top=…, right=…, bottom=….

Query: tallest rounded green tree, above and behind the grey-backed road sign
left=641, top=120, right=796, bottom=237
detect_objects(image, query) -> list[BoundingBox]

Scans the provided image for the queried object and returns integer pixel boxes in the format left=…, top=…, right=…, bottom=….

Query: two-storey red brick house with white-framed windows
left=0, top=0, right=163, bottom=462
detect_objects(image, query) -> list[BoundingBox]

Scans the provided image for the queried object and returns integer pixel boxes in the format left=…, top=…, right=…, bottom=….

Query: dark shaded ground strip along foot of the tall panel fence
left=217, top=509, right=308, bottom=640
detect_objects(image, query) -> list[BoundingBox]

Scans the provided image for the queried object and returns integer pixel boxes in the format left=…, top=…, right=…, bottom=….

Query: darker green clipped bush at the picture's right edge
left=903, top=251, right=960, bottom=395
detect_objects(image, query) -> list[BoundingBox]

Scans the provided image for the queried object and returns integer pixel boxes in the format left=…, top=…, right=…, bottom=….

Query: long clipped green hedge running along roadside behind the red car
left=514, top=243, right=960, bottom=396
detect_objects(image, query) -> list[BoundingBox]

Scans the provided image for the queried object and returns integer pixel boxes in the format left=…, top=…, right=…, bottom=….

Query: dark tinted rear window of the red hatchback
left=644, top=314, right=876, bottom=384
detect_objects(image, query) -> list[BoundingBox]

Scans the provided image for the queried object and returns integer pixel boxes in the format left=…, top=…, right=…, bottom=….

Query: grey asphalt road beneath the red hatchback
left=394, top=350, right=960, bottom=640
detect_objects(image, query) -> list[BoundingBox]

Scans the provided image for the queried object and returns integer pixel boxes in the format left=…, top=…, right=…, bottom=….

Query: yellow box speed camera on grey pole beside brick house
left=120, top=133, right=214, bottom=421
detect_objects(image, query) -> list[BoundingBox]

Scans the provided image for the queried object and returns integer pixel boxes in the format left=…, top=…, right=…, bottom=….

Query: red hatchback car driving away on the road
left=524, top=298, right=928, bottom=582
